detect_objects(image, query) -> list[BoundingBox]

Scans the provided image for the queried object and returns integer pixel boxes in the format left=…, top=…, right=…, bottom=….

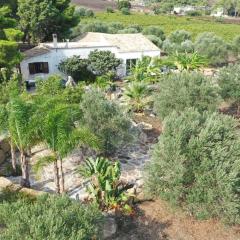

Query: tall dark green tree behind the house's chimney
left=17, top=0, right=79, bottom=42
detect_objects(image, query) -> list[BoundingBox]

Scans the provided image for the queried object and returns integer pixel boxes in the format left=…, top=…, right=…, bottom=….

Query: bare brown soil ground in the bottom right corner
left=113, top=200, right=240, bottom=240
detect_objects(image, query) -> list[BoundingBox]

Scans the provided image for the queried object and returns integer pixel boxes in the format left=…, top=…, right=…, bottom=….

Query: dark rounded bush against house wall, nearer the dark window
left=58, top=56, right=95, bottom=82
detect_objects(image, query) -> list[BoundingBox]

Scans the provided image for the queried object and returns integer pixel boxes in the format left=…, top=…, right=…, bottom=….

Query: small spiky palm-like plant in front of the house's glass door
left=124, top=82, right=150, bottom=112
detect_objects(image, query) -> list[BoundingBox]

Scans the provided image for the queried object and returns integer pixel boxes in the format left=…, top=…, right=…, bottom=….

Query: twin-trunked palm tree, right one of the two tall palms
left=34, top=98, right=98, bottom=194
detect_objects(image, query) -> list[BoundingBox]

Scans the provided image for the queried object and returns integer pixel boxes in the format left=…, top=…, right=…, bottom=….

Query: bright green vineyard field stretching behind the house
left=88, top=12, right=240, bottom=41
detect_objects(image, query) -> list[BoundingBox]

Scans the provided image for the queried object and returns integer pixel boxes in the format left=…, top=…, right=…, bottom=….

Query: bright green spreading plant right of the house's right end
left=174, top=52, right=207, bottom=71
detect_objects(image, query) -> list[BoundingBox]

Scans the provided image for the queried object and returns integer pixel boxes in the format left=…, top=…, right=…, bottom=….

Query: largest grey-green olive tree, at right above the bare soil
left=145, top=109, right=240, bottom=223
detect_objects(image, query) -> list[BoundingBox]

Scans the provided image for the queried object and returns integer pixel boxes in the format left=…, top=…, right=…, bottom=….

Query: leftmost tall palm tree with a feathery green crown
left=8, top=97, right=38, bottom=187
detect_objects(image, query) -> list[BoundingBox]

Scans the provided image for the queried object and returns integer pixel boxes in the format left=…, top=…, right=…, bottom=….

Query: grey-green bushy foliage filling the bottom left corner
left=0, top=195, right=102, bottom=240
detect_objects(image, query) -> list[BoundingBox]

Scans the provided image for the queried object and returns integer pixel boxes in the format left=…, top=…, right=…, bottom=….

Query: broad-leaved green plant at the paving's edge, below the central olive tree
left=78, top=157, right=133, bottom=210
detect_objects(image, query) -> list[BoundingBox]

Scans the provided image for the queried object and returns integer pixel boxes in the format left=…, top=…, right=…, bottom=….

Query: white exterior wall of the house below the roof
left=20, top=47, right=160, bottom=80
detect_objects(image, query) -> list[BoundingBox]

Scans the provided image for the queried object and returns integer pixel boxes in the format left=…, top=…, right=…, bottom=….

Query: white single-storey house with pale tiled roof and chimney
left=20, top=32, right=160, bottom=82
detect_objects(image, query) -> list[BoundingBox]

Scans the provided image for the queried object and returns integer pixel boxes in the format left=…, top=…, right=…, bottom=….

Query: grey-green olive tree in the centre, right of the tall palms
left=81, top=90, right=133, bottom=154
